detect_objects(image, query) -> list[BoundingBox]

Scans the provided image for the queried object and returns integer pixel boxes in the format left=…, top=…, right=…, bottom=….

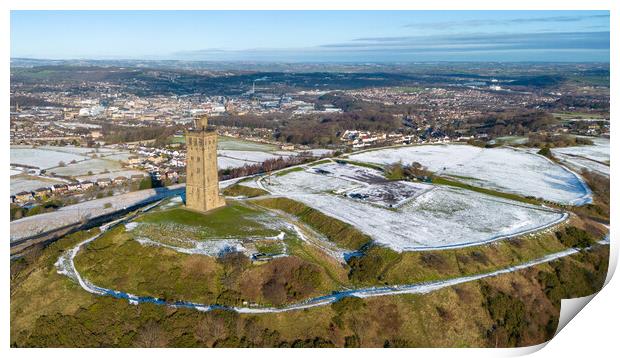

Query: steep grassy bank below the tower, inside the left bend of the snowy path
left=75, top=227, right=338, bottom=305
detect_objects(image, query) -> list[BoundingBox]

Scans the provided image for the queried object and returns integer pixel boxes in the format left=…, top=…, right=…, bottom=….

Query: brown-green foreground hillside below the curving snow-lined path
left=11, top=237, right=608, bottom=347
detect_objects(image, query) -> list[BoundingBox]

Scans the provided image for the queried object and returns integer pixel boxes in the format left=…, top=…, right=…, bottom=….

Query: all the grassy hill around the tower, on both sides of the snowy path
left=10, top=190, right=609, bottom=347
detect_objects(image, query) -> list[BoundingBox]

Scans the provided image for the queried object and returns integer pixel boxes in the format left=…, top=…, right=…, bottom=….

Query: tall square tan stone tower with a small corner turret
left=185, top=117, right=226, bottom=212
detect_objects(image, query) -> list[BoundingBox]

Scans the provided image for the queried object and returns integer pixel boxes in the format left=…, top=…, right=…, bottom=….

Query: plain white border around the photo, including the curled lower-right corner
left=0, top=0, right=620, bottom=358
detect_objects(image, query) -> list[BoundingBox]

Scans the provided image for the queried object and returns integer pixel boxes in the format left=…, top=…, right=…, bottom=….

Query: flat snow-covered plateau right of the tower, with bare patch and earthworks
left=260, top=164, right=566, bottom=251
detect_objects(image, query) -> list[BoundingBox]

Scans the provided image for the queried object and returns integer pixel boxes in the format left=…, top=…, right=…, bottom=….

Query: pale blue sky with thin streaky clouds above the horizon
left=11, top=11, right=609, bottom=62
